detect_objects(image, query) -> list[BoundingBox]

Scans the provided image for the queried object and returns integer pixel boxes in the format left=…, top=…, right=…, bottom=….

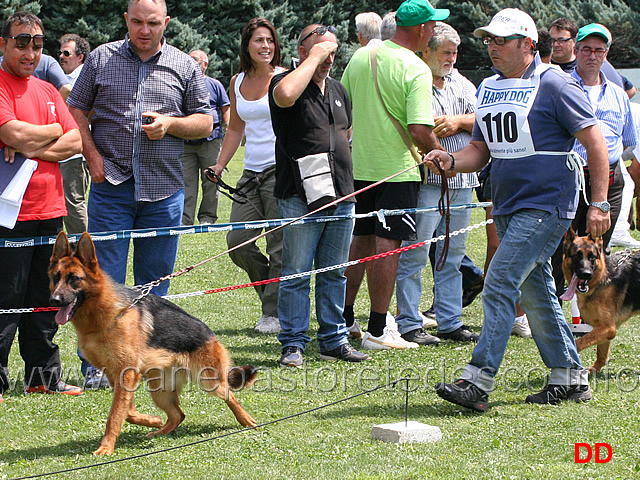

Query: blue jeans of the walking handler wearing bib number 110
left=461, top=209, right=588, bottom=392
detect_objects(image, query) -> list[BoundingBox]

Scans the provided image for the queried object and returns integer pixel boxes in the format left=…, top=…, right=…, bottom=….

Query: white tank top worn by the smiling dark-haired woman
left=234, top=67, right=284, bottom=172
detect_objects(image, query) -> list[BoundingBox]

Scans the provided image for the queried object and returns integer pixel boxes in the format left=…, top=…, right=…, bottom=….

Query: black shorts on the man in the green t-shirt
left=353, top=180, right=420, bottom=240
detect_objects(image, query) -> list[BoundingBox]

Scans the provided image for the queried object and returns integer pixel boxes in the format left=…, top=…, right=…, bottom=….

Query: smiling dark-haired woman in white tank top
left=210, top=18, right=284, bottom=333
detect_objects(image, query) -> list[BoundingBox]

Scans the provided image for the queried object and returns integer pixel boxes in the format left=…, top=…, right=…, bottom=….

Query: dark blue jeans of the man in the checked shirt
left=89, top=179, right=184, bottom=295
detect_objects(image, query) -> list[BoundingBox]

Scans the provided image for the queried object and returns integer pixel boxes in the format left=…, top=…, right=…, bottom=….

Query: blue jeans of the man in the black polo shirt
left=278, top=196, right=354, bottom=352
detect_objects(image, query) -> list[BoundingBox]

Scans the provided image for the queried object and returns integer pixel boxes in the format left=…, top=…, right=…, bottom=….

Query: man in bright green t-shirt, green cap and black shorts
left=342, top=0, right=449, bottom=350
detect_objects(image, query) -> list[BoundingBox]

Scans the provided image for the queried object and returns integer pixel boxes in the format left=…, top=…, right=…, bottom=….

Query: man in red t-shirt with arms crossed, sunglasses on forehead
left=0, top=12, right=83, bottom=402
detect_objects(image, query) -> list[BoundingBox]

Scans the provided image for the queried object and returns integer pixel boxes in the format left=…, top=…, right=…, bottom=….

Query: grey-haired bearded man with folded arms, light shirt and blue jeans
left=396, top=22, right=478, bottom=345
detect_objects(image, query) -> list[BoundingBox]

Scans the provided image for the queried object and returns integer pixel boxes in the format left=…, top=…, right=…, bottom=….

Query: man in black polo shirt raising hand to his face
left=269, top=24, right=370, bottom=368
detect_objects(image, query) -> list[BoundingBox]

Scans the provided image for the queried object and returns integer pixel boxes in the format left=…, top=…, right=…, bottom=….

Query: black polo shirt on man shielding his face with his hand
left=269, top=70, right=355, bottom=201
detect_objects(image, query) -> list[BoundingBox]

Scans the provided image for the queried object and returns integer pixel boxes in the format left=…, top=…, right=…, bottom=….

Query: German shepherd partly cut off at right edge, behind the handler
left=560, top=229, right=640, bottom=373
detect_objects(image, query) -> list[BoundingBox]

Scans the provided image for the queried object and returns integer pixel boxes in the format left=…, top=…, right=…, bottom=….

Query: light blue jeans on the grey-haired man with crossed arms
left=396, top=185, right=473, bottom=333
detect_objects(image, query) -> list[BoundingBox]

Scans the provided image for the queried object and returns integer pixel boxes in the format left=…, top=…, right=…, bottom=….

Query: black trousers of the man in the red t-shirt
left=0, top=218, right=62, bottom=393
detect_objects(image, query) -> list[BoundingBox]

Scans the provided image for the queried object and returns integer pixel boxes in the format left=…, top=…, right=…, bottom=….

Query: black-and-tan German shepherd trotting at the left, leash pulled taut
left=49, top=232, right=257, bottom=455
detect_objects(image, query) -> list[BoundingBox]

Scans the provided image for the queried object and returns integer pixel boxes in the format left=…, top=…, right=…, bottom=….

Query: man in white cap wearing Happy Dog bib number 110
left=427, top=8, right=611, bottom=412
